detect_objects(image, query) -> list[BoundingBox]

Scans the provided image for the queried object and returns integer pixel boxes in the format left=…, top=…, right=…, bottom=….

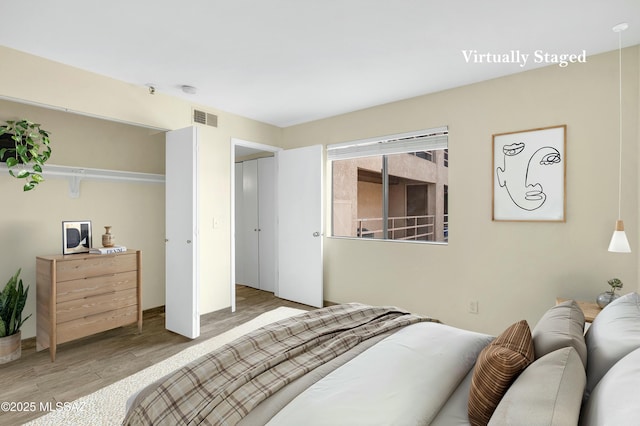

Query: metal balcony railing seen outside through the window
left=357, top=215, right=440, bottom=241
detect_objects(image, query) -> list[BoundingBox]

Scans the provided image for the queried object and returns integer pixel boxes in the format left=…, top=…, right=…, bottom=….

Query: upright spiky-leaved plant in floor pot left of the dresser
left=0, top=269, right=31, bottom=364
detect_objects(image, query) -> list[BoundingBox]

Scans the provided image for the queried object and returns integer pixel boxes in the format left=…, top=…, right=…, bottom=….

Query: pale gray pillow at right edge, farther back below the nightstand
left=585, top=293, right=640, bottom=398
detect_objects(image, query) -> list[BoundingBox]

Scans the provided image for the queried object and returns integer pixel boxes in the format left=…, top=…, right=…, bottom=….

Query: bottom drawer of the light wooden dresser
left=56, top=306, right=138, bottom=344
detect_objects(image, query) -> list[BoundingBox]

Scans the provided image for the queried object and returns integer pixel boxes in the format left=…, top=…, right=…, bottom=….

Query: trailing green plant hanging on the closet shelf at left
left=0, top=120, right=51, bottom=191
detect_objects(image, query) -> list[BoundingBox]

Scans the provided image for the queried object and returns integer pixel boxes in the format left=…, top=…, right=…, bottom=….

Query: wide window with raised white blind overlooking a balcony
left=327, top=127, right=449, bottom=243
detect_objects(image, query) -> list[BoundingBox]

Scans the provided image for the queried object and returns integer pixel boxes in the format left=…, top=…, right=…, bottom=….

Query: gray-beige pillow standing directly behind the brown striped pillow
left=531, top=300, right=587, bottom=368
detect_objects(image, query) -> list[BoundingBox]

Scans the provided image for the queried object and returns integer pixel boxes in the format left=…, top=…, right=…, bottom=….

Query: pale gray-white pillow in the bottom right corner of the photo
left=580, top=349, right=640, bottom=426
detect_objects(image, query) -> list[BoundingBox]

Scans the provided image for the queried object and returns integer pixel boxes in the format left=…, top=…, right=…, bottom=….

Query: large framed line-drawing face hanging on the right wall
left=492, top=125, right=567, bottom=222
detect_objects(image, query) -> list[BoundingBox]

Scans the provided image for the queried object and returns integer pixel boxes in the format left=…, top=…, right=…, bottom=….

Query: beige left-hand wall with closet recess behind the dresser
left=0, top=46, right=281, bottom=338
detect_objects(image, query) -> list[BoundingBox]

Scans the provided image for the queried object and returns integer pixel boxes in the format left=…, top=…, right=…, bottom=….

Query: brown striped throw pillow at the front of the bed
left=468, top=320, right=534, bottom=426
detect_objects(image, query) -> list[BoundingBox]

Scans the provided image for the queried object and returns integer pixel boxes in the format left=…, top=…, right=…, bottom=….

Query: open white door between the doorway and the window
left=276, top=145, right=323, bottom=307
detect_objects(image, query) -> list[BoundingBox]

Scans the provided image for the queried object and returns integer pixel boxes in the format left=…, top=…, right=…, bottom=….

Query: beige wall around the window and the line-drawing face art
left=283, top=46, right=640, bottom=334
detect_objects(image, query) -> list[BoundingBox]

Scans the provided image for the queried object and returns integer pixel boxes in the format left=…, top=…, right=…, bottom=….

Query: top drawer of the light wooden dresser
left=56, top=253, right=137, bottom=283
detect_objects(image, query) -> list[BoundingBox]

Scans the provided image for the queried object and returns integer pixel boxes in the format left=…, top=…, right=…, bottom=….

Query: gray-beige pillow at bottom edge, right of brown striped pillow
left=489, top=346, right=586, bottom=426
